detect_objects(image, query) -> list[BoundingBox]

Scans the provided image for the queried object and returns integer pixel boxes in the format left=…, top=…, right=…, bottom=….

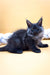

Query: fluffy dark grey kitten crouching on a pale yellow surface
left=0, top=18, right=48, bottom=53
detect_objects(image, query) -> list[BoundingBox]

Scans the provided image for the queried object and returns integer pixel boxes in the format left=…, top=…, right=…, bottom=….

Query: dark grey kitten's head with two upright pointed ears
left=26, top=18, right=43, bottom=37
